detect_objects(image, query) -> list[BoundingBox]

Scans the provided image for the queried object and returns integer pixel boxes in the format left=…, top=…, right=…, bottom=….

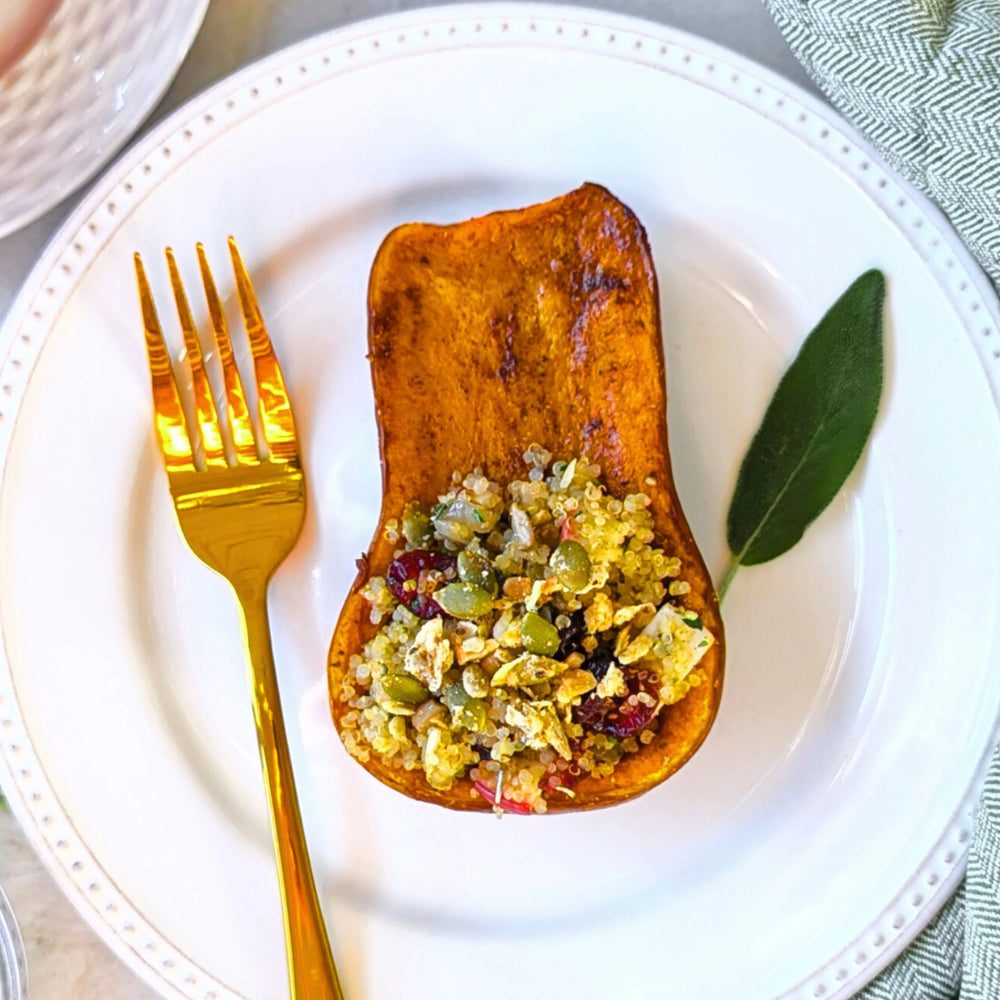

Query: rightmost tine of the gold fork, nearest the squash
left=229, top=236, right=299, bottom=462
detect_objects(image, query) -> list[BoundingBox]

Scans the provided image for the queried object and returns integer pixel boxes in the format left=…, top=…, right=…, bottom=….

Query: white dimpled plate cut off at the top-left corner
left=0, top=0, right=208, bottom=236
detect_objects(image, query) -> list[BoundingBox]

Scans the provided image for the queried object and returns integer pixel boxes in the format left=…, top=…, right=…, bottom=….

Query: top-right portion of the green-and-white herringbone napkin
left=764, top=0, right=1000, bottom=292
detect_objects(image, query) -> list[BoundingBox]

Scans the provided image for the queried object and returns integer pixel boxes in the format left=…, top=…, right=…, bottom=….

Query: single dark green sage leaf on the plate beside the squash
left=719, top=270, right=885, bottom=597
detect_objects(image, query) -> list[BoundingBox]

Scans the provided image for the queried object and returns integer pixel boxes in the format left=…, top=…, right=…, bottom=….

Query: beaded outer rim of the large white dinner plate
left=0, top=4, right=1000, bottom=1000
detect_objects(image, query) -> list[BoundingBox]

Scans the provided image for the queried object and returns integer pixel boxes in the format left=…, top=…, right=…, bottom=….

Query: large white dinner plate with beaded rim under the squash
left=0, top=5, right=1000, bottom=1000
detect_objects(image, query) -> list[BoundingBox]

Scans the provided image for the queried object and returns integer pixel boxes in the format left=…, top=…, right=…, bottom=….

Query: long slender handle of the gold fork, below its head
left=234, top=579, right=344, bottom=1000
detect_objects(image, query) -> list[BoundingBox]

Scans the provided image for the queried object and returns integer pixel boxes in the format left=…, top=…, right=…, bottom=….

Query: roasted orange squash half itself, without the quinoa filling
left=328, top=184, right=725, bottom=812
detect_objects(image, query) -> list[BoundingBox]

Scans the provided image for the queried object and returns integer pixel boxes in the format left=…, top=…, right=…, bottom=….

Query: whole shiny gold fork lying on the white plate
left=135, top=238, right=344, bottom=1000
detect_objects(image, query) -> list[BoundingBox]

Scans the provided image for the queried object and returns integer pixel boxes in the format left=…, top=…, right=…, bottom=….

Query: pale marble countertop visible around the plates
left=0, top=0, right=815, bottom=1000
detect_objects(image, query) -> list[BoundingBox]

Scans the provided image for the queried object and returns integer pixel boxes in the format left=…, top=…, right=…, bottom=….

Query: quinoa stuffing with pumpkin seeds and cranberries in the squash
left=342, top=445, right=714, bottom=813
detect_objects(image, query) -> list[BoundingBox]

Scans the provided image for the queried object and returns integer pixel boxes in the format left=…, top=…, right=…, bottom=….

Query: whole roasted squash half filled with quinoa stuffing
left=329, top=184, right=724, bottom=814
